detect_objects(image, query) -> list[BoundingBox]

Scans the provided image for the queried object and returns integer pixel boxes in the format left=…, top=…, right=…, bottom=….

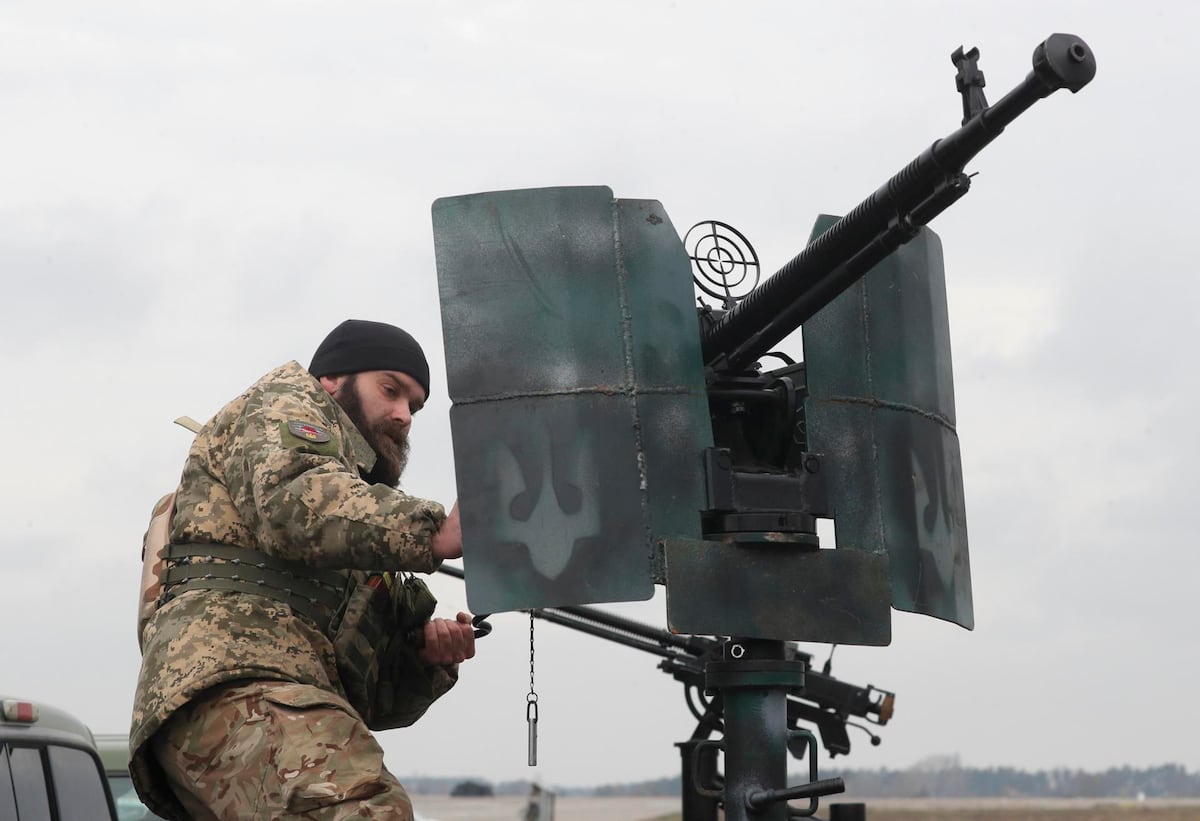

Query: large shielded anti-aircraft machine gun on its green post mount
left=433, top=34, right=1096, bottom=821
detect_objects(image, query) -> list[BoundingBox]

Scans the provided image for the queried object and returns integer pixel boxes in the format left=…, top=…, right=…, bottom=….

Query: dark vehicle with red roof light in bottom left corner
left=0, top=697, right=116, bottom=821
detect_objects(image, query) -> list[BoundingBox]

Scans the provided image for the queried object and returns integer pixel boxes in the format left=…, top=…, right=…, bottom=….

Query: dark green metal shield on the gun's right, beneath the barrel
left=802, top=215, right=974, bottom=628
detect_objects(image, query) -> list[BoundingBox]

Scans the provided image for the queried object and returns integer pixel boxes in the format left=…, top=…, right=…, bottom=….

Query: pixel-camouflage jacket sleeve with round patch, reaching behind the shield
left=223, top=367, right=445, bottom=573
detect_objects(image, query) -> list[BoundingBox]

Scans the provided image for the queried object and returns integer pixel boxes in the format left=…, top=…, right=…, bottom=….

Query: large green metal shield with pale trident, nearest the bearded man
left=433, top=187, right=712, bottom=612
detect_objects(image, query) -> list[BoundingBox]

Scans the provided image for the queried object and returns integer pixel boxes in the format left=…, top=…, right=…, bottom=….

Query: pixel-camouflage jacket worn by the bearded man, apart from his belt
left=130, top=362, right=455, bottom=816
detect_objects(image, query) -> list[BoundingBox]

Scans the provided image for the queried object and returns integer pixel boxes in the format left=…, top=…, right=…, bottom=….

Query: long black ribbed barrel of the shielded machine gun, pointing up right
left=701, top=34, right=1096, bottom=372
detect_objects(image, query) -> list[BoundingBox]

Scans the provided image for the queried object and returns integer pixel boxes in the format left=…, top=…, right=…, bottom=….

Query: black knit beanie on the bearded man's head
left=308, top=319, right=430, bottom=397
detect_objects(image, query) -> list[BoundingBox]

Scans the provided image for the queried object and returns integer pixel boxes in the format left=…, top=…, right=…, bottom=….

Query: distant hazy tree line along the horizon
left=400, top=765, right=1200, bottom=798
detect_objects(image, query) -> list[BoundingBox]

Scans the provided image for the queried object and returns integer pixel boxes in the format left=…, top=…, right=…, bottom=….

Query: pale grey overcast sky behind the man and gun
left=0, top=0, right=1200, bottom=785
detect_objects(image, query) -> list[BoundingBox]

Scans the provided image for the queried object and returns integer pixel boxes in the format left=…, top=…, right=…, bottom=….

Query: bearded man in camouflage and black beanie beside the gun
left=130, top=319, right=474, bottom=821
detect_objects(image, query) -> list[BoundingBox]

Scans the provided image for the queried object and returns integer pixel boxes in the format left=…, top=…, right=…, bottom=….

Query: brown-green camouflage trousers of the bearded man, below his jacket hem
left=151, top=681, right=413, bottom=821
